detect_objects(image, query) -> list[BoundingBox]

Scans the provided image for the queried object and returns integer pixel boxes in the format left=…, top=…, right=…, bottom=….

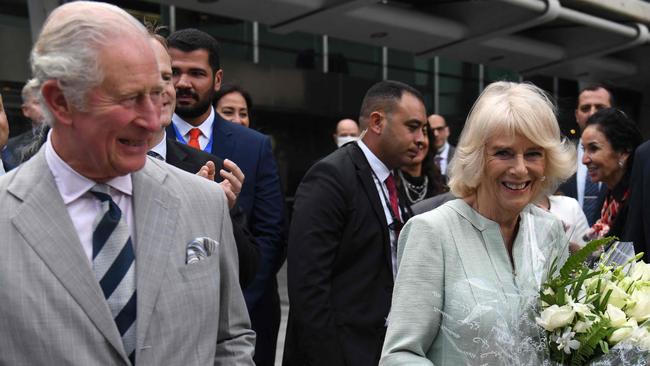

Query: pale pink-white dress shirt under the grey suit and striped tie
left=45, top=131, right=135, bottom=262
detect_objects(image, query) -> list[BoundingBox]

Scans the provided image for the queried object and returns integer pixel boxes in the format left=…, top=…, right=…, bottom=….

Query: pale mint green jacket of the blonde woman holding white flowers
left=380, top=199, right=568, bottom=366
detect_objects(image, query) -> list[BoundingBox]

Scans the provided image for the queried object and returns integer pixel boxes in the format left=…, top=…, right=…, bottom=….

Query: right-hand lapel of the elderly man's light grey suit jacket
left=132, top=159, right=179, bottom=347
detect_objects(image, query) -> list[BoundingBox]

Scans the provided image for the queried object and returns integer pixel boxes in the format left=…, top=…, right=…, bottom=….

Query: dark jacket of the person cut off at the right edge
left=621, top=141, right=650, bottom=263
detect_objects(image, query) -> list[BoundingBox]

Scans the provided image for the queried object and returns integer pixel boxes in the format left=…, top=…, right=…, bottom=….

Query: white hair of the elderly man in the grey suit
left=30, top=1, right=147, bottom=125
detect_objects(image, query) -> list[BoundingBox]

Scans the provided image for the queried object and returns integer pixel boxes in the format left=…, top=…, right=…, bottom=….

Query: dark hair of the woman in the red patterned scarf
left=587, top=108, right=643, bottom=170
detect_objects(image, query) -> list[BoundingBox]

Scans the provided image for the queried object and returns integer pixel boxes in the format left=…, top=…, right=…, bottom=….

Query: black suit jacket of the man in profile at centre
left=284, top=143, right=406, bottom=366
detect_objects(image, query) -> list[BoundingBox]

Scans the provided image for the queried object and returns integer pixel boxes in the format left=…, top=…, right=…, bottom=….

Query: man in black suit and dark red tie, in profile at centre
left=284, top=81, right=427, bottom=366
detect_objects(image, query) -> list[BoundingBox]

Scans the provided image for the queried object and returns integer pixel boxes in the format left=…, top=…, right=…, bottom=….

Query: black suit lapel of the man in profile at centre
left=348, top=143, right=393, bottom=268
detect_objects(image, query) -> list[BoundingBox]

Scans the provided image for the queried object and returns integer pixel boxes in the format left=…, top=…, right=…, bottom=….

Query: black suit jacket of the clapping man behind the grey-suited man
left=166, top=139, right=260, bottom=288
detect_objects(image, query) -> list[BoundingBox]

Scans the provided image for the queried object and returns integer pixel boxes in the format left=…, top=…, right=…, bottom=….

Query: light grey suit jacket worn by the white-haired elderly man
left=0, top=149, right=255, bottom=365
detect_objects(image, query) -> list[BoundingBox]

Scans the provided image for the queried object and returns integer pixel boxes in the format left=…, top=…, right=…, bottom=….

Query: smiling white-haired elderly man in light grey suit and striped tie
left=0, top=2, right=255, bottom=365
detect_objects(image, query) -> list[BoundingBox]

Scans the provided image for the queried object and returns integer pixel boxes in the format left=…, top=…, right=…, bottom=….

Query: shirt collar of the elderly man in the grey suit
left=45, top=130, right=133, bottom=205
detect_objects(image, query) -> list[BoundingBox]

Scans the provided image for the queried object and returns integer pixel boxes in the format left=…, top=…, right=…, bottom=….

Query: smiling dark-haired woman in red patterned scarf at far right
left=582, top=108, right=642, bottom=239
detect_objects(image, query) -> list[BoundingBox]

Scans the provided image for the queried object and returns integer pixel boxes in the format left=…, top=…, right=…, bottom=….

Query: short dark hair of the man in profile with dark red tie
left=359, top=80, right=424, bottom=129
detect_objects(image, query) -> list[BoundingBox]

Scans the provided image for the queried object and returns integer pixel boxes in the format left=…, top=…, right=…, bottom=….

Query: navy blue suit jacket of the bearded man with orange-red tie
left=167, top=112, right=284, bottom=309
